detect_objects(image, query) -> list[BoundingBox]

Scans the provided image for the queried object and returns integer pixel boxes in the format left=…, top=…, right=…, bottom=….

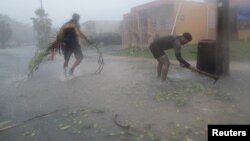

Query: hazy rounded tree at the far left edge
left=0, top=21, right=12, bottom=47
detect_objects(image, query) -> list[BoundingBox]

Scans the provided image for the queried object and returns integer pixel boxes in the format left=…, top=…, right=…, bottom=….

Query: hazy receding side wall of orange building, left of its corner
left=123, top=0, right=174, bottom=47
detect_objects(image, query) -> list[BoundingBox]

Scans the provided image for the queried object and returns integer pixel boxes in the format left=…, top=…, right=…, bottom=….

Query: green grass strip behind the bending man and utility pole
left=112, top=41, right=250, bottom=62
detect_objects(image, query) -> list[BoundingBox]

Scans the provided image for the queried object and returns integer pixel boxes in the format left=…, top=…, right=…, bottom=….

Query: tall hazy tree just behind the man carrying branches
left=31, top=8, right=51, bottom=49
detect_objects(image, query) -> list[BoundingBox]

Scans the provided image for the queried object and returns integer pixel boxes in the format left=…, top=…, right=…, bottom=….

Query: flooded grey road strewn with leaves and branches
left=0, top=46, right=250, bottom=141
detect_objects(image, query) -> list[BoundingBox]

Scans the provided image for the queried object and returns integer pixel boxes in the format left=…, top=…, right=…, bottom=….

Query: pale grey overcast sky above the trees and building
left=0, top=0, right=154, bottom=27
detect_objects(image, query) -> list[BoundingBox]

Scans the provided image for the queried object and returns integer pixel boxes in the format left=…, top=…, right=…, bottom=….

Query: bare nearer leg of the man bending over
left=157, top=55, right=170, bottom=81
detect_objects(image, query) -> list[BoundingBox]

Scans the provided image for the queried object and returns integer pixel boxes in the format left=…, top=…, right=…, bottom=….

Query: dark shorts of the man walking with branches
left=63, top=42, right=83, bottom=61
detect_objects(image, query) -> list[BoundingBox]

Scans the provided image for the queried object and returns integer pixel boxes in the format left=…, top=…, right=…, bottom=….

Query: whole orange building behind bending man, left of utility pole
left=122, top=0, right=216, bottom=47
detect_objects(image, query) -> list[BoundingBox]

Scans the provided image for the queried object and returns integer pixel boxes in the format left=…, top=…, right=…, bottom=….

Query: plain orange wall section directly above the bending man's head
left=175, top=1, right=216, bottom=43
